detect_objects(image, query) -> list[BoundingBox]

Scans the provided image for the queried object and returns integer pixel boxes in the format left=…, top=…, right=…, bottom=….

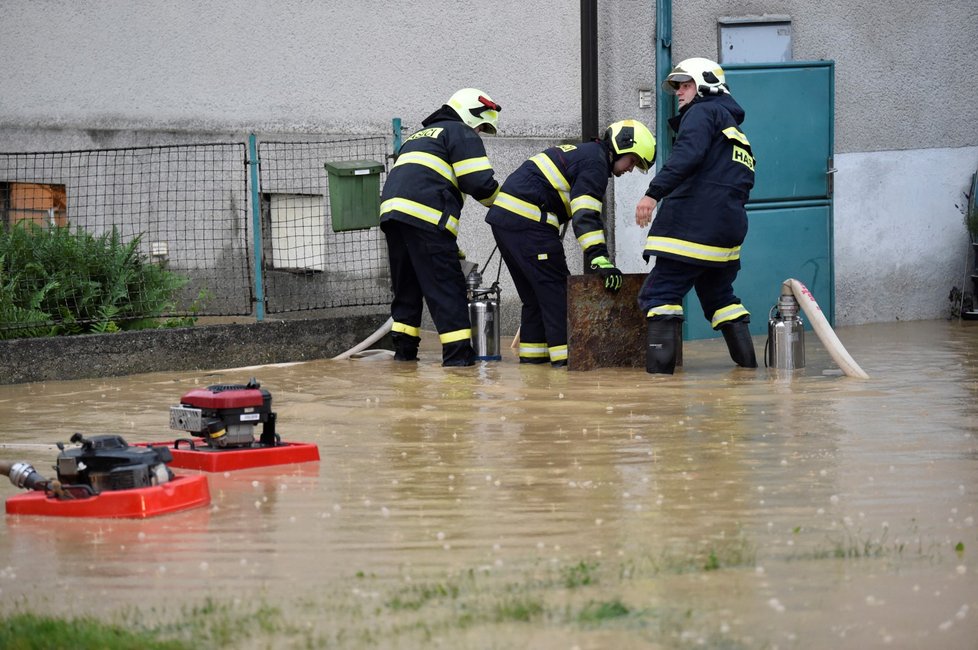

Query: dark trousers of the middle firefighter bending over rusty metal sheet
left=492, top=225, right=570, bottom=365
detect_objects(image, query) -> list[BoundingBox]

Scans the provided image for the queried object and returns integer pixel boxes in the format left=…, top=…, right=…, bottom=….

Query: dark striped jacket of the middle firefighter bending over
left=486, top=140, right=613, bottom=263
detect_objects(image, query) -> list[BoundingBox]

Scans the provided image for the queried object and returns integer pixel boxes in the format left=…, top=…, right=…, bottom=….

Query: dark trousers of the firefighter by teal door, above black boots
left=638, top=257, right=750, bottom=329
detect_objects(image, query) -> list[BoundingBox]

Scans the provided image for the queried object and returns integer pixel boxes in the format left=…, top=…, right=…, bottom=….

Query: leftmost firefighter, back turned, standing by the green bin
left=380, top=88, right=500, bottom=366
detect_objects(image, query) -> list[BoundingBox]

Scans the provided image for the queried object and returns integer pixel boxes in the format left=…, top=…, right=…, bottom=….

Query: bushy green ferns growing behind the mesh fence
left=0, top=224, right=204, bottom=339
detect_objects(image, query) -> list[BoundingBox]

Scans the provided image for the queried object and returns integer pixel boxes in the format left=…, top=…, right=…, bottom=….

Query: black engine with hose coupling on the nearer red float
left=0, top=433, right=173, bottom=499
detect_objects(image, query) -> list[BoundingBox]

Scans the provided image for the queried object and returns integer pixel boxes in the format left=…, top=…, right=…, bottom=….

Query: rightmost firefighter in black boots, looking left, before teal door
left=635, top=58, right=757, bottom=374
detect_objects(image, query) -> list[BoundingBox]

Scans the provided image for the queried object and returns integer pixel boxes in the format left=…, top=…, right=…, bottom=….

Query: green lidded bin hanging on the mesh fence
left=325, top=160, right=384, bottom=232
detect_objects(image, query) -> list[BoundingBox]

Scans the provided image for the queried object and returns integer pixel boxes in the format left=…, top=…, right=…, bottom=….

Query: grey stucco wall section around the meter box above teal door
left=672, top=0, right=978, bottom=153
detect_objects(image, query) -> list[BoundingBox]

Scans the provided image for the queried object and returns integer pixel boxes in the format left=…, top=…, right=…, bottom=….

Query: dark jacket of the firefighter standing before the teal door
left=642, top=94, right=754, bottom=266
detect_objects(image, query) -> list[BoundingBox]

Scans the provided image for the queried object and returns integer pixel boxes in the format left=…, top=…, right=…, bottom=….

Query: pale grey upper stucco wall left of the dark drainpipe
left=0, top=0, right=580, bottom=136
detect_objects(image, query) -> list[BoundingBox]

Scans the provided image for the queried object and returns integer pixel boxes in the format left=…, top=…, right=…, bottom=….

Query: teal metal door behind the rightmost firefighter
left=684, top=61, right=835, bottom=339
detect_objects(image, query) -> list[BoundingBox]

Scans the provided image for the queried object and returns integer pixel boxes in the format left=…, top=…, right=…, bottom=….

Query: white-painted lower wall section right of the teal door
left=834, top=147, right=978, bottom=325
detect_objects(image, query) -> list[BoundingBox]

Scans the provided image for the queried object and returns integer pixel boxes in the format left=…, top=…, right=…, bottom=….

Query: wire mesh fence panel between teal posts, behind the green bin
left=258, top=137, right=390, bottom=313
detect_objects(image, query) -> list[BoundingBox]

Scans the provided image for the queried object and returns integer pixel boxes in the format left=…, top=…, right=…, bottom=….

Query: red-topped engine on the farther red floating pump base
left=170, top=378, right=281, bottom=449
